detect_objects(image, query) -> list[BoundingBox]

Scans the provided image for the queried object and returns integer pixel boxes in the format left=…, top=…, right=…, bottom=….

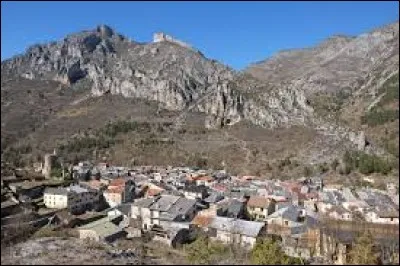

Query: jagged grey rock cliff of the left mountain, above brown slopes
left=2, top=26, right=316, bottom=130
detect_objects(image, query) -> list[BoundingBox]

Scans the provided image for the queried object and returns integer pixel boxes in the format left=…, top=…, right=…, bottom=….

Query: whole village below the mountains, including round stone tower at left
left=1, top=151, right=399, bottom=264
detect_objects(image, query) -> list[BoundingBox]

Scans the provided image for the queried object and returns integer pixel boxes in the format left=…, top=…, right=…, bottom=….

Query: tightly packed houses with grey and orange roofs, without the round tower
left=1, top=162, right=399, bottom=262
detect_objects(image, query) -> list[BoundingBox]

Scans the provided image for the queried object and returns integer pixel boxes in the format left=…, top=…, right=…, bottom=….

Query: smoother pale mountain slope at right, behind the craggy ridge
left=245, top=22, right=399, bottom=160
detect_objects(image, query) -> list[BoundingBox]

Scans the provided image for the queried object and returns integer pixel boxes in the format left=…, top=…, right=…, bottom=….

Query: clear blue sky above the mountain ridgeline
left=1, top=1, right=399, bottom=69
